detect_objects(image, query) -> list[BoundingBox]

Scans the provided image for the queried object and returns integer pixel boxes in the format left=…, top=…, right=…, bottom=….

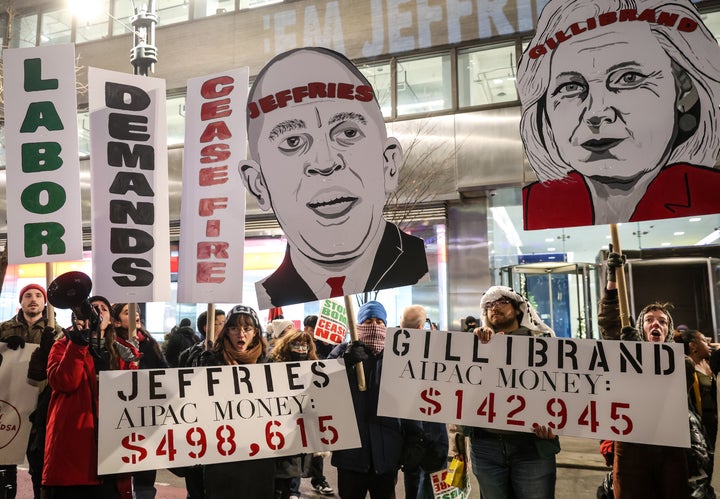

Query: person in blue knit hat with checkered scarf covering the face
left=329, top=301, right=419, bottom=499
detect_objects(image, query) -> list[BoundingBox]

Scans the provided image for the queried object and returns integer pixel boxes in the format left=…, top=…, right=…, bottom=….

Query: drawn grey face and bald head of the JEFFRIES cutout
left=241, top=51, right=402, bottom=262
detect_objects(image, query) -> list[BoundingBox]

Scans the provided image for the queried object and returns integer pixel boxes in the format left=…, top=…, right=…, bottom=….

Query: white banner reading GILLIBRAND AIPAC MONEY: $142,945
left=378, top=328, right=690, bottom=447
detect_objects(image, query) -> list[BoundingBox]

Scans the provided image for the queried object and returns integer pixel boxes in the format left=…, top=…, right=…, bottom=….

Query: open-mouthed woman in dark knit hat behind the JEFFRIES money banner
left=195, top=305, right=275, bottom=499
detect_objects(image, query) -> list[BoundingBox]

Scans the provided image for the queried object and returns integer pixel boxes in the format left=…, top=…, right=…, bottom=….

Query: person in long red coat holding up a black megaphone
left=43, top=296, right=137, bottom=499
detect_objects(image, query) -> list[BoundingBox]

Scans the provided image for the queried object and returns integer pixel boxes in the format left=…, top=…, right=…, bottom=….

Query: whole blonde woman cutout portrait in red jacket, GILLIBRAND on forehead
left=518, top=0, right=720, bottom=229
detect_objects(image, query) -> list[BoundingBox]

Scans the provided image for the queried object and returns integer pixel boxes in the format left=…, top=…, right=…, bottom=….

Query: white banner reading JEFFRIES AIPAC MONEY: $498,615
left=98, top=361, right=360, bottom=475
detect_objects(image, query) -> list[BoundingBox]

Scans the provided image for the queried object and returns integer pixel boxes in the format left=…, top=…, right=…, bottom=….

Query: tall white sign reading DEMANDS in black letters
left=88, top=68, right=170, bottom=302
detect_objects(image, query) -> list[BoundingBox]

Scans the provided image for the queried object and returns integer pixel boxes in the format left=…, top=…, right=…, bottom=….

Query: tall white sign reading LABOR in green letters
left=3, top=45, right=82, bottom=264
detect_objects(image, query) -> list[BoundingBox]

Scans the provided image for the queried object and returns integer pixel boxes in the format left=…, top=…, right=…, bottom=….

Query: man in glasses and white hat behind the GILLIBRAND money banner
left=470, top=286, right=560, bottom=499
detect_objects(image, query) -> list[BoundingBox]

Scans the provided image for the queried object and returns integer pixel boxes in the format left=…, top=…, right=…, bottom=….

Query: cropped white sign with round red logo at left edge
left=0, top=343, right=39, bottom=465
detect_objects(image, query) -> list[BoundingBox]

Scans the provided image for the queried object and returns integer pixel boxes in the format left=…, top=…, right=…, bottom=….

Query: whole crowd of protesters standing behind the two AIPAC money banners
left=0, top=270, right=720, bottom=499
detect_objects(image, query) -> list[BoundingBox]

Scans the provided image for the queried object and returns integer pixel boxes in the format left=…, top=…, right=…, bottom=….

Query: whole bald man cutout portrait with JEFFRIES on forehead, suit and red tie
left=240, top=47, right=428, bottom=309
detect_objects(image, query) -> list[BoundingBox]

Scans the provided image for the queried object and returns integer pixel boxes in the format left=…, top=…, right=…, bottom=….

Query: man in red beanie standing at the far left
left=0, top=284, right=62, bottom=499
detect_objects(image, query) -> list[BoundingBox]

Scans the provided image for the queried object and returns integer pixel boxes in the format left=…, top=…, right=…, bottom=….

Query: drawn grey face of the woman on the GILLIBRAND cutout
left=546, top=22, right=677, bottom=181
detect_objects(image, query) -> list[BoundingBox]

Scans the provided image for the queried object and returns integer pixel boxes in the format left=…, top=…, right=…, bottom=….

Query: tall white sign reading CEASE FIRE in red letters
left=178, top=68, right=248, bottom=303
